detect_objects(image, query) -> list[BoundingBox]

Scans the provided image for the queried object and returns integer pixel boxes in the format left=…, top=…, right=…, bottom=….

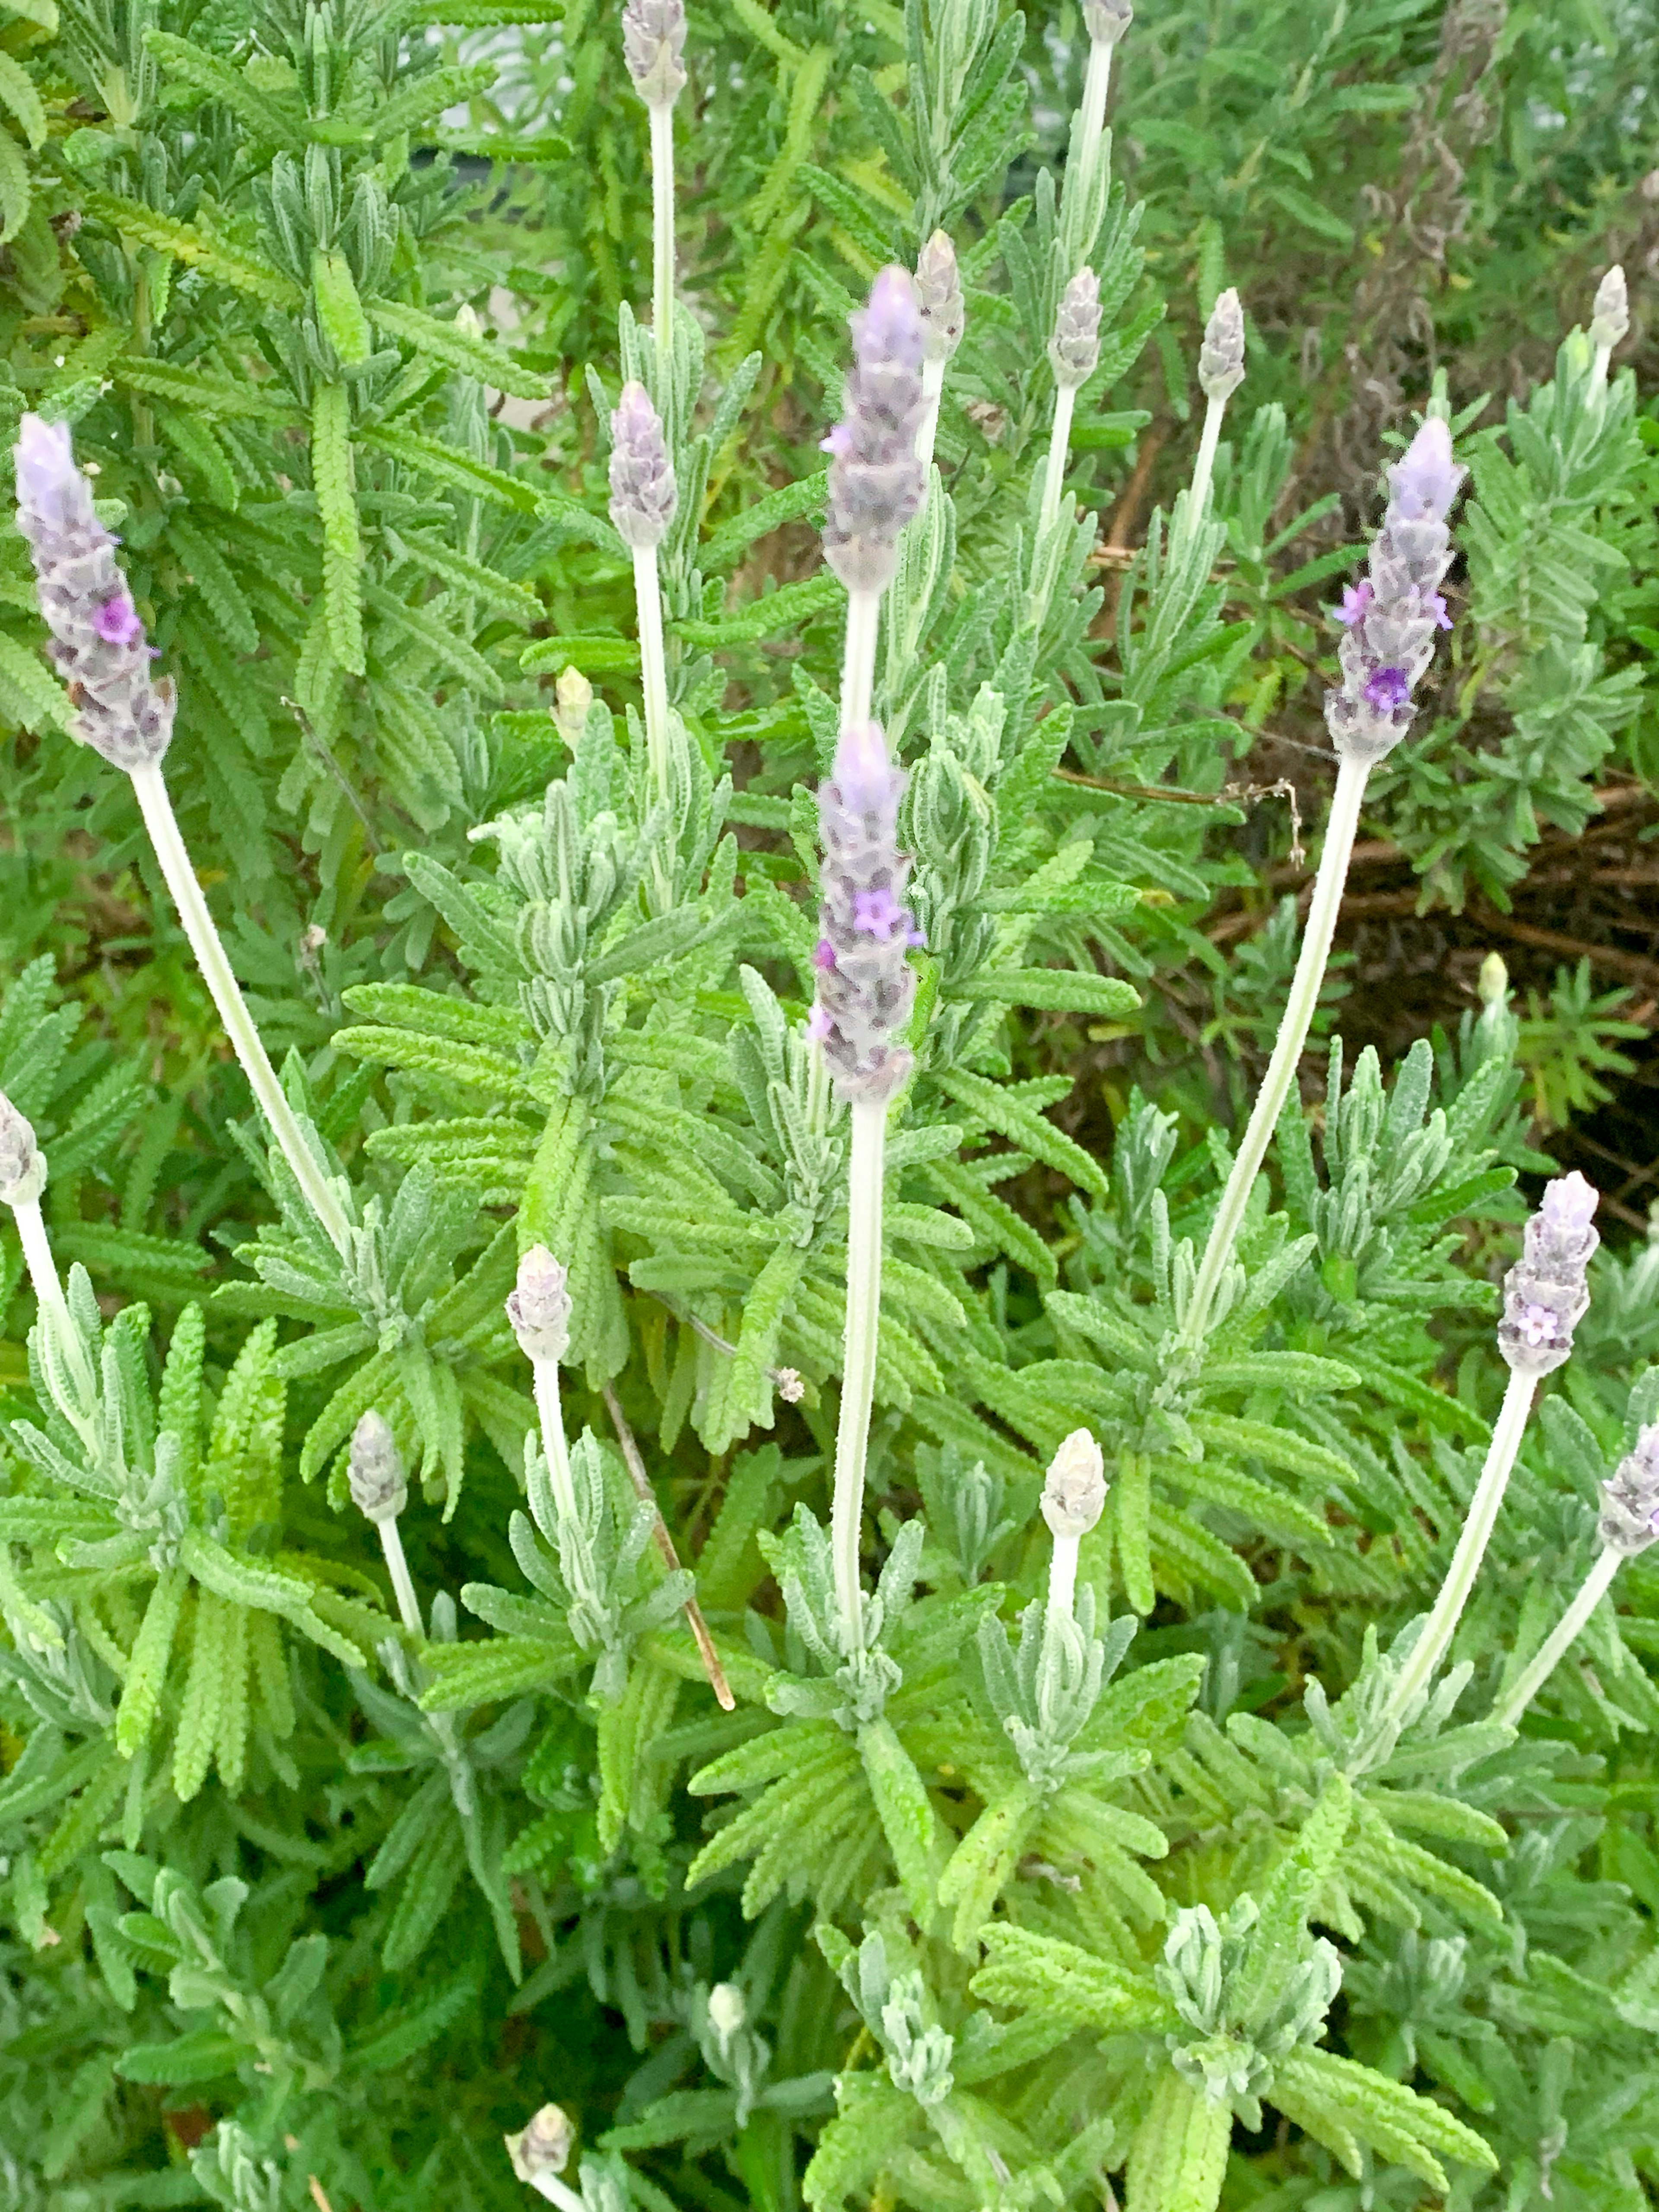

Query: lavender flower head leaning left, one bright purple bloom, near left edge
left=16, top=416, right=172, bottom=772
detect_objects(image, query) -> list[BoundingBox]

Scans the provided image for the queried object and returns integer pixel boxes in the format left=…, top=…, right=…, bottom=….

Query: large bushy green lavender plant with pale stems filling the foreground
left=0, top=0, right=1659, bottom=2212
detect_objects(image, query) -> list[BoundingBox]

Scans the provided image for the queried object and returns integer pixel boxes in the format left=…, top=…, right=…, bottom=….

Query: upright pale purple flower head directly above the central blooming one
left=823, top=268, right=927, bottom=591
